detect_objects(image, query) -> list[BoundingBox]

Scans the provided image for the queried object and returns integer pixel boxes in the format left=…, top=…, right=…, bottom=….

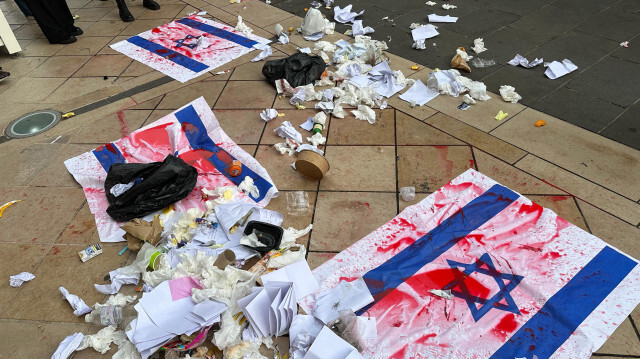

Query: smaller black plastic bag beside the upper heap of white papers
left=262, top=52, right=327, bottom=87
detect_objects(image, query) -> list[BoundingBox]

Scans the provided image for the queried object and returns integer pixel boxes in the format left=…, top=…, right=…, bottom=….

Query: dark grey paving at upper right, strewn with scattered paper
left=272, top=0, right=640, bottom=149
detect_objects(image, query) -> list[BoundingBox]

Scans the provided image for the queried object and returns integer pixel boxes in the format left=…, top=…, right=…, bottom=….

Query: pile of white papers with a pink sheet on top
left=127, top=277, right=227, bottom=359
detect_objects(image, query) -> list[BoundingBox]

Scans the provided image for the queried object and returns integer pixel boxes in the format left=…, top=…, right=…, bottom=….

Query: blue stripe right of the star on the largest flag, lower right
left=491, top=246, right=637, bottom=359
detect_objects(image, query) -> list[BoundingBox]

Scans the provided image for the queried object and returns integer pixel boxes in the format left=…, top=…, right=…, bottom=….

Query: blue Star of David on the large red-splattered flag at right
left=443, top=253, right=524, bottom=322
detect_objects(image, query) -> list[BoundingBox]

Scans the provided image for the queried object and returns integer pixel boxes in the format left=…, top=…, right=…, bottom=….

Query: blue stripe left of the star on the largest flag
left=358, top=184, right=519, bottom=314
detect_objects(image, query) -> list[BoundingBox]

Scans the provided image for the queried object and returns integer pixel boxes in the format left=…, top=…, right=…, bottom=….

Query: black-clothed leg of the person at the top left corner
left=25, top=0, right=77, bottom=44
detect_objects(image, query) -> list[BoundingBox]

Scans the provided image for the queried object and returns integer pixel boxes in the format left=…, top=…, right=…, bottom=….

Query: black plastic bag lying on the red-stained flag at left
left=104, top=155, right=198, bottom=222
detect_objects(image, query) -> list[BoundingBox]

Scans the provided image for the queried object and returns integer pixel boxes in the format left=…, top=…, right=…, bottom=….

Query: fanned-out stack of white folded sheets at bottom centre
left=238, top=281, right=298, bottom=340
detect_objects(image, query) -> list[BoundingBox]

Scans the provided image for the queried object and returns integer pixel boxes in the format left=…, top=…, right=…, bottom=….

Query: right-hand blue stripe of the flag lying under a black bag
left=176, top=105, right=273, bottom=202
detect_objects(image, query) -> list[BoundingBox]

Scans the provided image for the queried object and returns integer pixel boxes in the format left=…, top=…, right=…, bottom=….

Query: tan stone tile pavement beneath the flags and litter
left=0, top=0, right=640, bottom=359
